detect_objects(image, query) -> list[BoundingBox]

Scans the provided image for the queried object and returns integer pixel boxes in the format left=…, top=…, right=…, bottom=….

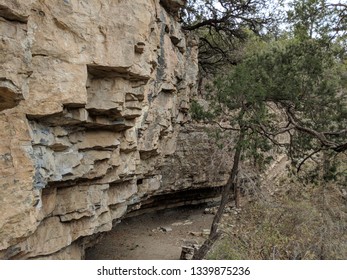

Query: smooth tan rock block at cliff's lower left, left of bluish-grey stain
left=0, top=113, right=40, bottom=250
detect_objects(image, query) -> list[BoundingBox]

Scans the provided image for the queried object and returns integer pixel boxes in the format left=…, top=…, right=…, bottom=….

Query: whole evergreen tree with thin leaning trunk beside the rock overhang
left=195, top=0, right=347, bottom=258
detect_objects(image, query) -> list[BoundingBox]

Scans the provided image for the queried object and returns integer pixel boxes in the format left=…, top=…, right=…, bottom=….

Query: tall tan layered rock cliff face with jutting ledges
left=0, top=0, right=234, bottom=259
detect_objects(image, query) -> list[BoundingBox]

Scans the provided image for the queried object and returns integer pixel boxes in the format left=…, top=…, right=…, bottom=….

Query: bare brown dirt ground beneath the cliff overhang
left=86, top=203, right=213, bottom=260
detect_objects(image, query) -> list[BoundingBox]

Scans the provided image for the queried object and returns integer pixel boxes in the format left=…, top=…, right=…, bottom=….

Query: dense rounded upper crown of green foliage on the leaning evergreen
left=215, top=40, right=337, bottom=107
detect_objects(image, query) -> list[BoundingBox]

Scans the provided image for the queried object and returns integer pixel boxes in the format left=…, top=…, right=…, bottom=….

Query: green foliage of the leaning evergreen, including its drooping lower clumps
left=213, top=36, right=347, bottom=173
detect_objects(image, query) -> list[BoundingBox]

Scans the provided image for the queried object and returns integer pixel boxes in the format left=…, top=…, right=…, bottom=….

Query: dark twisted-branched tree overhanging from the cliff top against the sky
left=182, top=0, right=272, bottom=75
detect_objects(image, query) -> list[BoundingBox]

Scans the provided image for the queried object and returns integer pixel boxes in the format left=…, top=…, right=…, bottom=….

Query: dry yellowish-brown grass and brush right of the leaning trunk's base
left=207, top=170, right=347, bottom=260
